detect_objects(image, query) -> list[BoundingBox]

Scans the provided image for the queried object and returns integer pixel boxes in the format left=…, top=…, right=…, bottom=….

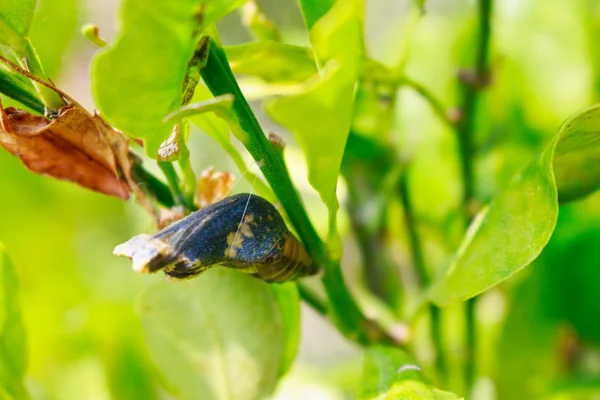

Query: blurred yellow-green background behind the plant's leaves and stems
left=0, top=0, right=600, bottom=400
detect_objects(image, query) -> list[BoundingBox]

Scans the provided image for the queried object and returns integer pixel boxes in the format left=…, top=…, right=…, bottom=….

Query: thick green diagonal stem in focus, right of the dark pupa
left=201, top=40, right=386, bottom=343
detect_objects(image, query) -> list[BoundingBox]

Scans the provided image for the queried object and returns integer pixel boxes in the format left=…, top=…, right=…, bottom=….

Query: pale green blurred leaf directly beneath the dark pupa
left=139, top=268, right=284, bottom=400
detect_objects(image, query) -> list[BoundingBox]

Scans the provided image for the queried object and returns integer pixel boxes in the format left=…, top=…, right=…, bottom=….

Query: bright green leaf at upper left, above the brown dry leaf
left=92, top=0, right=244, bottom=158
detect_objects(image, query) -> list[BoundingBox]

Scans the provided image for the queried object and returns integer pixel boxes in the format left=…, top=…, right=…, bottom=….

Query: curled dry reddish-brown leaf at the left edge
left=0, top=103, right=140, bottom=199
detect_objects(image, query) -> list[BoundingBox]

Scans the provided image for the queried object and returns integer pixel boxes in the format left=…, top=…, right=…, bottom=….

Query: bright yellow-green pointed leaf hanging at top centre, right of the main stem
left=267, top=0, right=363, bottom=244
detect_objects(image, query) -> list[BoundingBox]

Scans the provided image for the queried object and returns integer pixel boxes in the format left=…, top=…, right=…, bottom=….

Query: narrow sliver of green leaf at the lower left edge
left=0, top=244, right=27, bottom=399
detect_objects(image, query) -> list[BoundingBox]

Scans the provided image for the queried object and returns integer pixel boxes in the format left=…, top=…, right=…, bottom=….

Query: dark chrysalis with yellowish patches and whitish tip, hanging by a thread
left=114, top=193, right=317, bottom=282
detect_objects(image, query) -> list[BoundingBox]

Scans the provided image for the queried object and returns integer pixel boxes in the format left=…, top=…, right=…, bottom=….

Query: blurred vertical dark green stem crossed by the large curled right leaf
left=456, top=0, right=492, bottom=390
